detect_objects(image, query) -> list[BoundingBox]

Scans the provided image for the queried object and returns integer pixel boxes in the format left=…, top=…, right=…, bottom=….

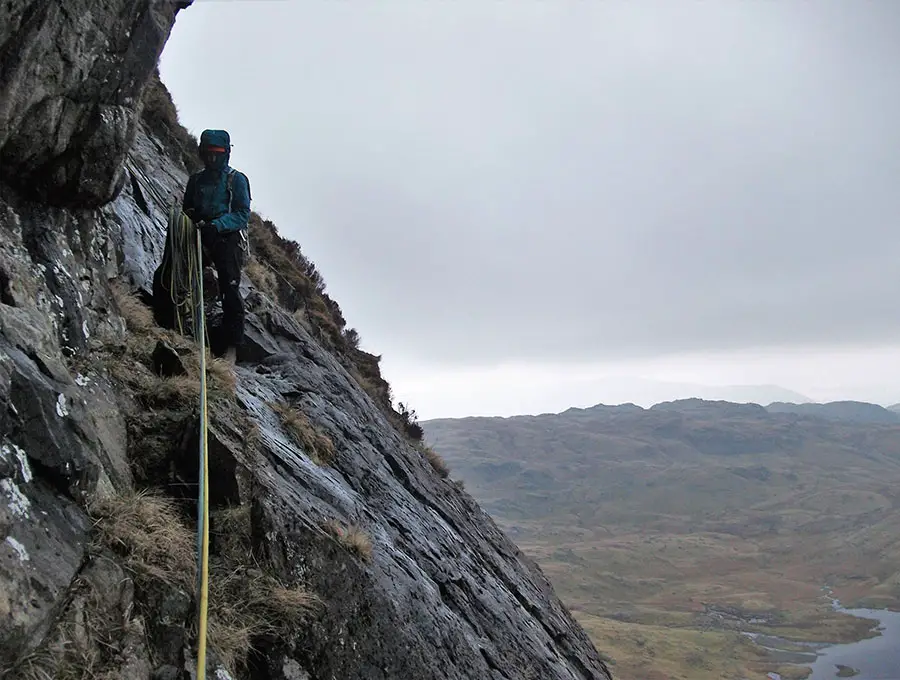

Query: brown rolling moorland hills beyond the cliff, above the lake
left=422, top=399, right=900, bottom=678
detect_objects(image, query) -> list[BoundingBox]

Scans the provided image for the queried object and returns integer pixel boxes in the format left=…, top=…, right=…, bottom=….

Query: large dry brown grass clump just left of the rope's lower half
left=89, top=491, right=196, bottom=589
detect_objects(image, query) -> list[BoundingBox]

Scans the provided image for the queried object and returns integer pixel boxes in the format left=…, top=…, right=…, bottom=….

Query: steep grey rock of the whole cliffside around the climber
left=0, top=0, right=610, bottom=680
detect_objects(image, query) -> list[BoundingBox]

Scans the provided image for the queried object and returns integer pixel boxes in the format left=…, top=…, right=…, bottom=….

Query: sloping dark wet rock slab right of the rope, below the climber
left=221, top=319, right=604, bottom=679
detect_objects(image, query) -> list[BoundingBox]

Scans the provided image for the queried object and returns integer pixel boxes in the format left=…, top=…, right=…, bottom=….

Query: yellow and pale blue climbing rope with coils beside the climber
left=162, top=208, right=209, bottom=680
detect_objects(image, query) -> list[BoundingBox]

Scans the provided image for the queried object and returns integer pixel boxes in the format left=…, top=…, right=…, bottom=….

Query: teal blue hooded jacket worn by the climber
left=182, top=131, right=250, bottom=234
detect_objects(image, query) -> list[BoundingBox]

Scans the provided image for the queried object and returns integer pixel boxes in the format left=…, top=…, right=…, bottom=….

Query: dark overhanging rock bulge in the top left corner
left=0, top=0, right=190, bottom=206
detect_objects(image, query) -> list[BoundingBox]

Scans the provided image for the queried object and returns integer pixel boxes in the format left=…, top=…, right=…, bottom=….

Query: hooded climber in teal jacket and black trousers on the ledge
left=182, top=130, right=250, bottom=364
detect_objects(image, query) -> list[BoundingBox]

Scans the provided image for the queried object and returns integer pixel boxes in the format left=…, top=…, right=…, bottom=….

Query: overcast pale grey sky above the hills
left=160, top=0, right=900, bottom=418
